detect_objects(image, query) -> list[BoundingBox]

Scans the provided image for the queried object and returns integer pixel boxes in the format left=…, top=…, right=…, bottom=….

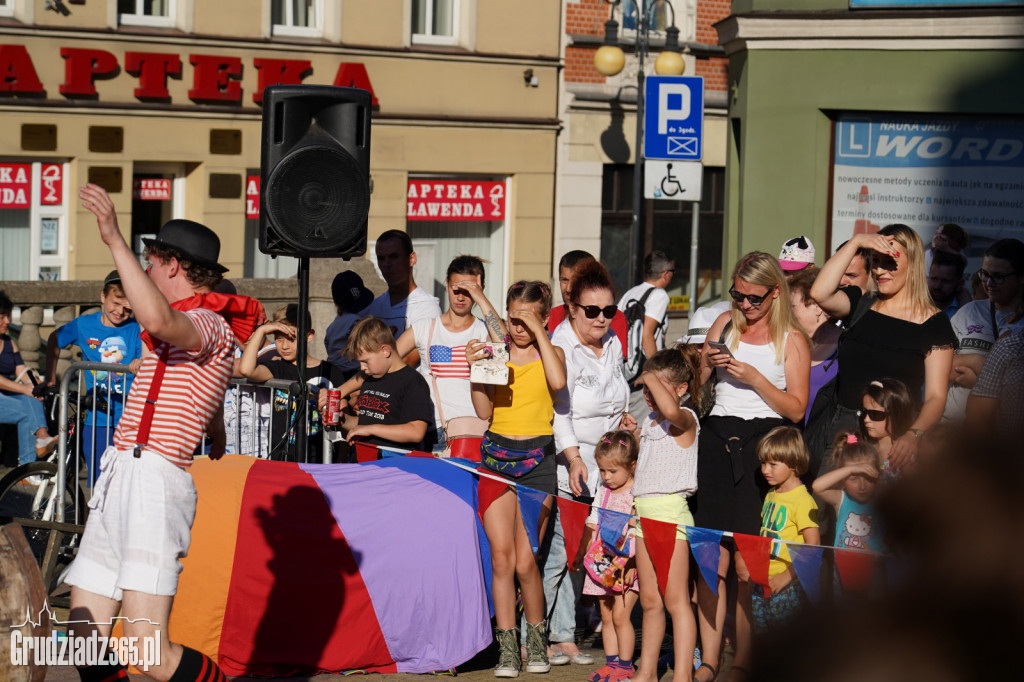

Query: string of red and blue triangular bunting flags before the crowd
left=355, top=443, right=882, bottom=599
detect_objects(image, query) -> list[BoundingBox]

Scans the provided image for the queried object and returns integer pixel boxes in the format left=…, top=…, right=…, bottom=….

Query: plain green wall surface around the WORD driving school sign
left=723, top=9, right=1024, bottom=276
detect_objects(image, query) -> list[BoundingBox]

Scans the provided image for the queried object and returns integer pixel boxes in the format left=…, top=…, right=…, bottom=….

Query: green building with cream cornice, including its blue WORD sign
left=717, top=0, right=1024, bottom=266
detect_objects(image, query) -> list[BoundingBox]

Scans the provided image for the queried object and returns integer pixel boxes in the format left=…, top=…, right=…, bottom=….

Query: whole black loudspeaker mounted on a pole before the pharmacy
left=259, top=85, right=372, bottom=258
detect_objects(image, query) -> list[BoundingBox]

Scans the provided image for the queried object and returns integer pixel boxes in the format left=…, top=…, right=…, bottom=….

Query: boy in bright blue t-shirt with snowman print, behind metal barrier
left=46, top=270, right=142, bottom=485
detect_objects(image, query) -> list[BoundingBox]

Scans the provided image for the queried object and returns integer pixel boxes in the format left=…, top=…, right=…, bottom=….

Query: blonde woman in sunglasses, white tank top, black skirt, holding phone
left=694, top=252, right=811, bottom=680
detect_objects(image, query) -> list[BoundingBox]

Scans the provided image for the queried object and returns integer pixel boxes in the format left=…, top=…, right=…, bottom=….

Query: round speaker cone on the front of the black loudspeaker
left=264, top=144, right=370, bottom=255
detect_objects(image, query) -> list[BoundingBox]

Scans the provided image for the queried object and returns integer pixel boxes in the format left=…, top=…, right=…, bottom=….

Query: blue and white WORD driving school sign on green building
left=831, top=113, right=1024, bottom=251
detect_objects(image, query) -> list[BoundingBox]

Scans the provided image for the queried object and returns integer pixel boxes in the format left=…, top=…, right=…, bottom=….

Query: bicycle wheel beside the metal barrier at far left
left=0, top=462, right=88, bottom=592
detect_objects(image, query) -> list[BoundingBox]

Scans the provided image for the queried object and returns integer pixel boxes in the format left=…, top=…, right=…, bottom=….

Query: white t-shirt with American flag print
left=413, top=317, right=488, bottom=427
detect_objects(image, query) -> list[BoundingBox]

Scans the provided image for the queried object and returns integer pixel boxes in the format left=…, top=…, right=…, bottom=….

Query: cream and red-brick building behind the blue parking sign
left=555, top=0, right=729, bottom=305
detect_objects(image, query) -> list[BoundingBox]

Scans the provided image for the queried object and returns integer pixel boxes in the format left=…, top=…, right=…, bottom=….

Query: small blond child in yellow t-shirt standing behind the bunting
left=754, top=426, right=821, bottom=633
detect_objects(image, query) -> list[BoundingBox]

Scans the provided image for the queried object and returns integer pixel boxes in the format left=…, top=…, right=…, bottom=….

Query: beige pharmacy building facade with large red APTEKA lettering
left=0, top=0, right=560, bottom=307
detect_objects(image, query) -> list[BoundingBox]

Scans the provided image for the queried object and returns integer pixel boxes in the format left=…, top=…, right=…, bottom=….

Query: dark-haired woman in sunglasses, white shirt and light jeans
left=544, top=258, right=636, bottom=665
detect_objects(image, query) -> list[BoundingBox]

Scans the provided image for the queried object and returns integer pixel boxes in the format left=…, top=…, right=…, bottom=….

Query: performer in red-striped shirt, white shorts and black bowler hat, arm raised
left=67, top=184, right=258, bottom=682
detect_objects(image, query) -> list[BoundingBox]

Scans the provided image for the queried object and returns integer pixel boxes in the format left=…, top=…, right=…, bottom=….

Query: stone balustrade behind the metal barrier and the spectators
left=0, top=258, right=384, bottom=379
